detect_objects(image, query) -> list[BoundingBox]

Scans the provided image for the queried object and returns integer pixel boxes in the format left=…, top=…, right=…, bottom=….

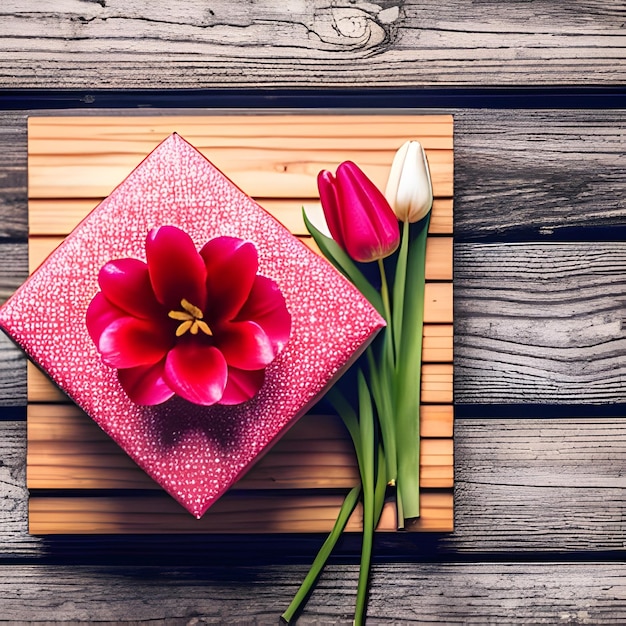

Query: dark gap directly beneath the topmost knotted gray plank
left=0, top=86, right=626, bottom=111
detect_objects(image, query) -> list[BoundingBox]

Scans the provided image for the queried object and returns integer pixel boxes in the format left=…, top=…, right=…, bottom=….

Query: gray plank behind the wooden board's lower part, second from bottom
left=0, top=417, right=626, bottom=562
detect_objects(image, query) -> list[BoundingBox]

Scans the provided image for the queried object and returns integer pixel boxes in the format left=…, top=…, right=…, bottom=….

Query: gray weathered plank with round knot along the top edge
left=0, top=0, right=626, bottom=90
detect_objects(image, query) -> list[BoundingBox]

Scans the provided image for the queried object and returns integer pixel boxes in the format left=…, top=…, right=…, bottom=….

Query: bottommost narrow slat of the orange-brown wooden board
left=29, top=490, right=453, bottom=535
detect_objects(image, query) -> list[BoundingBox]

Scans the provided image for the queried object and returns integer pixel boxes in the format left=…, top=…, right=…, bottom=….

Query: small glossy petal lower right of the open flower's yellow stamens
left=216, top=322, right=276, bottom=370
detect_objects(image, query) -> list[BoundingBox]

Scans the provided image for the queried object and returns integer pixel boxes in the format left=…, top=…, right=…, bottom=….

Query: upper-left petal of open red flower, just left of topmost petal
left=98, top=259, right=161, bottom=318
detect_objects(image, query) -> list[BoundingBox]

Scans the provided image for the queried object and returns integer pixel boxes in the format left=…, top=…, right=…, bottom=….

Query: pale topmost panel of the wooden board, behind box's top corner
left=28, top=115, right=453, bottom=197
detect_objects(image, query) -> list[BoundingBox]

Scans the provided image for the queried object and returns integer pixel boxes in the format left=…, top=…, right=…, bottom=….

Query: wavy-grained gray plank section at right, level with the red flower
left=454, top=242, right=626, bottom=404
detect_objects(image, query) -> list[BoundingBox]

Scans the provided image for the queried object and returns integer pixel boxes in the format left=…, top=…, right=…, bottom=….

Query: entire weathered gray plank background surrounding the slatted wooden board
left=0, top=0, right=626, bottom=624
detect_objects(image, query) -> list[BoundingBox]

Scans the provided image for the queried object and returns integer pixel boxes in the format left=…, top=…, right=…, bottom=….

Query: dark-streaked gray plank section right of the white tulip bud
left=454, top=109, right=626, bottom=241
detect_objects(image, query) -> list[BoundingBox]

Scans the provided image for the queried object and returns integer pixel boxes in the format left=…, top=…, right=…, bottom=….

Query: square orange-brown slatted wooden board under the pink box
left=27, top=115, right=454, bottom=534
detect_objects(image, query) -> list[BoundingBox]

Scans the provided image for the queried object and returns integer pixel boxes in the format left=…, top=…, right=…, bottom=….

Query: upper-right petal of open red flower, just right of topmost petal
left=200, top=237, right=259, bottom=323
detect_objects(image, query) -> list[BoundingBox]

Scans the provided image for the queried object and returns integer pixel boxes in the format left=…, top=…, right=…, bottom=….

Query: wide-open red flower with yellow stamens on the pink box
left=87, top=226, right=291, bottom=405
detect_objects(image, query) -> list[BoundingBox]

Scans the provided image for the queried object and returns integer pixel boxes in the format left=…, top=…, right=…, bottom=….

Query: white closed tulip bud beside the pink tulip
left=385, top=141, right=433, bottom=222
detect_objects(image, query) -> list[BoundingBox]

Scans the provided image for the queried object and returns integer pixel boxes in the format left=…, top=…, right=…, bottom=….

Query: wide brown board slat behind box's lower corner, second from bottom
left=27, top=404, right=453, bottom=489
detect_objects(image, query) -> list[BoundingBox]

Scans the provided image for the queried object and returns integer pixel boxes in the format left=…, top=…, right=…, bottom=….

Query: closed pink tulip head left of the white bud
left=317, top=161, right=400, bottom=263
